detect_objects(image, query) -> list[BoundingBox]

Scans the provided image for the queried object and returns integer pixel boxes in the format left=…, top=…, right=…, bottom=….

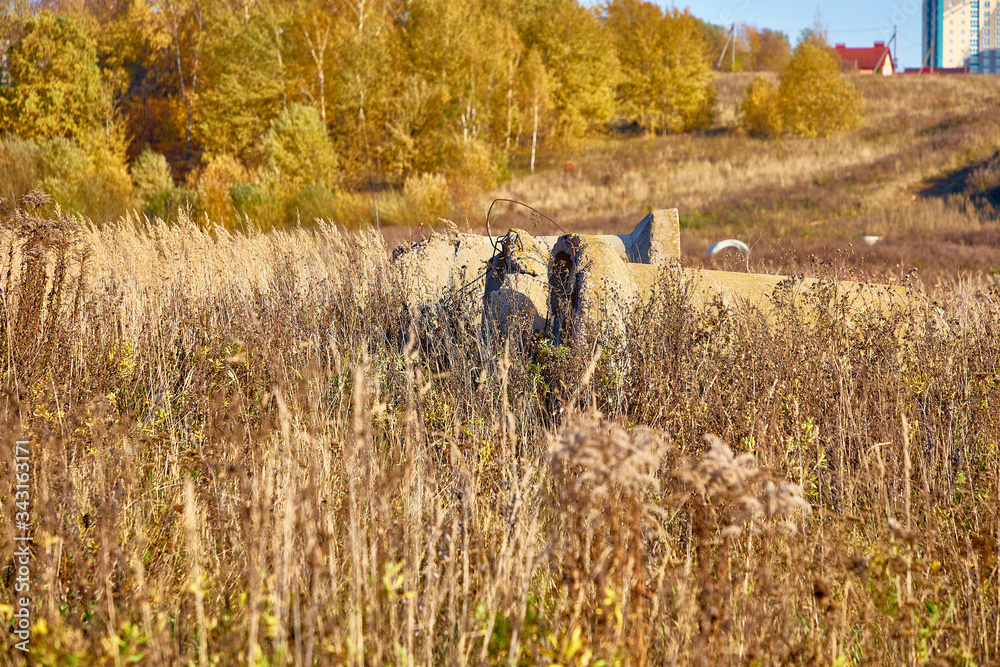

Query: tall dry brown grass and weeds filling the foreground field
left=0, top=190, right=1000, bottom=665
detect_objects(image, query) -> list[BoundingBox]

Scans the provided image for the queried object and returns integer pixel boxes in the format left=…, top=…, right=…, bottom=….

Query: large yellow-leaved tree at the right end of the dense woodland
left=605, top=0, right=715, bottom=132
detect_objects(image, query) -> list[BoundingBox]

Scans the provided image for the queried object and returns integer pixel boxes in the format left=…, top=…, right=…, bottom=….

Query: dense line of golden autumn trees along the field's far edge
left=0, top=0, right=788, bottom=222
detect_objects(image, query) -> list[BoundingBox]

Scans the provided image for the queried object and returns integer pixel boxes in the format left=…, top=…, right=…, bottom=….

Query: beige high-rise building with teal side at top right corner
left=923, top=0, right=1000, bottom=74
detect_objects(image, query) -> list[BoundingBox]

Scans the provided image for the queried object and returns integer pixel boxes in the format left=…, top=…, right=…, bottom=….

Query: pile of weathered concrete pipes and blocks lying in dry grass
left=394, top=209, right=919, bottom=344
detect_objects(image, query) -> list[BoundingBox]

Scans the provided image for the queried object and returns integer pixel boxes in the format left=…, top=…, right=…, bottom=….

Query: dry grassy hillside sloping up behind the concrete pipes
left=442, top=74, right=1000, bottom=281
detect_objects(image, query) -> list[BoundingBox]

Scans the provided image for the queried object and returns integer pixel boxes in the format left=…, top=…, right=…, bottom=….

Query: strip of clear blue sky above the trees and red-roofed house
left=668, top=0, right=923, bottom=67
